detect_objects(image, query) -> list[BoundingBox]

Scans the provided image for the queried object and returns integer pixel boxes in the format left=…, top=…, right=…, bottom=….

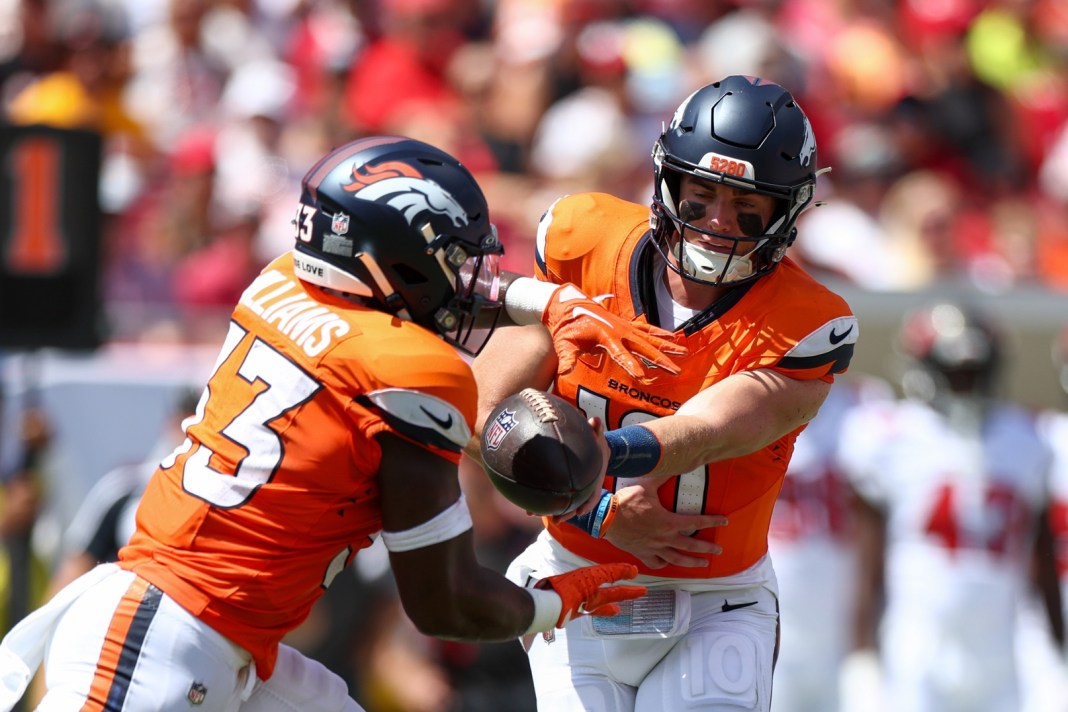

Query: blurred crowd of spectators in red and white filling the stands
left=0, top=0, right=1068, bottom=712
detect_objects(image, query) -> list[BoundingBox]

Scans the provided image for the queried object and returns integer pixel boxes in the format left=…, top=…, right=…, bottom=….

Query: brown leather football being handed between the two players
left=482, top=389, right=603, bottom=517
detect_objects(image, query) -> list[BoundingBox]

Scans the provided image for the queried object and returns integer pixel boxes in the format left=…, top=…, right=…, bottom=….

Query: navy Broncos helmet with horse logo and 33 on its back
left=293, top=136, right=503, bottom=353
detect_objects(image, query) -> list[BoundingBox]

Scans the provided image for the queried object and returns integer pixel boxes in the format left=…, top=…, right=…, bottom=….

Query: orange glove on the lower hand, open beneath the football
left=534, top=564, right=648, bottom=628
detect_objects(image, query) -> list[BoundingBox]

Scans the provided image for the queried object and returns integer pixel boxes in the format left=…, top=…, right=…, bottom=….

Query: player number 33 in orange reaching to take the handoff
left=0, top=137, right=678, bottom=712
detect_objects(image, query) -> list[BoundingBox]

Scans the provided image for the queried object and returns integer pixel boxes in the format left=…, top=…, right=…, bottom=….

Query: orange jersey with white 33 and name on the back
left=120, top=254, right=476, bottom=679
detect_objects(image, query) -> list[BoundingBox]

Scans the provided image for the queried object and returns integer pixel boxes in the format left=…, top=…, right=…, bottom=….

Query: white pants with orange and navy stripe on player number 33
left=0, top=565, right=363, bottom=712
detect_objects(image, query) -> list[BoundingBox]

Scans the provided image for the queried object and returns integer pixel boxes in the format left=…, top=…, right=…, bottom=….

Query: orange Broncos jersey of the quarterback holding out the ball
left=535, top=193, right=858, bottom=579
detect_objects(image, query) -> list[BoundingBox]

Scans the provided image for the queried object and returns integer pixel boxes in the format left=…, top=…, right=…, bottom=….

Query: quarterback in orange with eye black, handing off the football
left=468, top=76, right=859, bottom=712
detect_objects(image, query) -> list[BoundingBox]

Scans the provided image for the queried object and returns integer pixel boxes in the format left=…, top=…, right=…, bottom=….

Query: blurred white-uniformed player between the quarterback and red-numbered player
left=768, top=377, right=893, bottom=712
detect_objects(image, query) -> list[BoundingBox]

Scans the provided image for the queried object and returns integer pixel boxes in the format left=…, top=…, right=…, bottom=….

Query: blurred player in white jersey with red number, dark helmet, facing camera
left=841, top=303, right=1063, bottom=712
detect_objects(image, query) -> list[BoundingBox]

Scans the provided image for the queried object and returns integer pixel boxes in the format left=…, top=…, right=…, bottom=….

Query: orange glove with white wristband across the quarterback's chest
left=541, top=284, right=687, bottom=380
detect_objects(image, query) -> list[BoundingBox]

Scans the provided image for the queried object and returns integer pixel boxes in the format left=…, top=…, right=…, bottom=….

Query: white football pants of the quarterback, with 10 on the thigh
left=507, top=536, right=779, bottom=712
